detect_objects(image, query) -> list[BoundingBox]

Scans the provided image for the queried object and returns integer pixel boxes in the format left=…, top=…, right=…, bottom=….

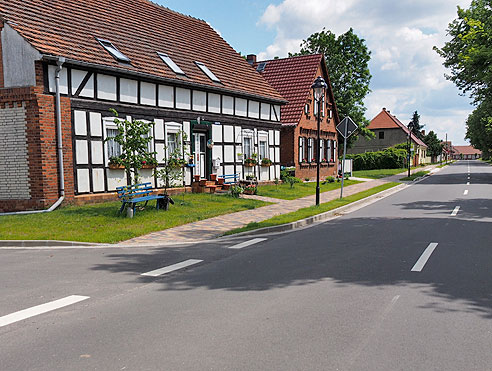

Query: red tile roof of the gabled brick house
left=253, top=54, right=323, bottom=125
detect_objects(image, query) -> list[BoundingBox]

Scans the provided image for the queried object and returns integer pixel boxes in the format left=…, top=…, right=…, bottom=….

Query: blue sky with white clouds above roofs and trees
left=157, top=0, right=473, bottom=145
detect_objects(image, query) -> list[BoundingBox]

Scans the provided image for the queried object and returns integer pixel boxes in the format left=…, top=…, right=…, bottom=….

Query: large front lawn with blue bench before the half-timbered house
left=0, top=193, right=268, bottom=243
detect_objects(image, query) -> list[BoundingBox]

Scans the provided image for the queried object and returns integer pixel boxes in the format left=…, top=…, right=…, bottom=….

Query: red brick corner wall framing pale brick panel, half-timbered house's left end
left=0, top=84, right=74, bottom=212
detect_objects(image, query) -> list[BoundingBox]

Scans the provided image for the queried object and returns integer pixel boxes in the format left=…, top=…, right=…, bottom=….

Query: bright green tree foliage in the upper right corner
left=434, top=0, right=492, bottom=103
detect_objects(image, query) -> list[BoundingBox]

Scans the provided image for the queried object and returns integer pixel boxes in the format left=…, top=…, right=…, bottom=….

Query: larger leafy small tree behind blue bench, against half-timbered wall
left=105, top=109, right=157, bottom=184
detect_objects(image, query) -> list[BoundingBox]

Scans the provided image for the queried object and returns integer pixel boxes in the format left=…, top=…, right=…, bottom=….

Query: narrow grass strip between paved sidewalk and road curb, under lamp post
left=225, top=182, right=400, bottom=235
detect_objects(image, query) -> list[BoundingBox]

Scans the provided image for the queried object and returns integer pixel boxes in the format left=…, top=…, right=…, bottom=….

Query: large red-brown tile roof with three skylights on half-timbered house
left=0, top=0, right=284, bottom=101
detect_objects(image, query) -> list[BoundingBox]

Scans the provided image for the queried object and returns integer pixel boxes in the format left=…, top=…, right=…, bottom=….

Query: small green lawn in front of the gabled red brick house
left=258, top=180, right=360, bottom=200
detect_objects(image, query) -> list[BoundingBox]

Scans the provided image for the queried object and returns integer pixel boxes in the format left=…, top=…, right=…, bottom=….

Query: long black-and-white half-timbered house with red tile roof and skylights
left=0, top=0, right=284, bottom=212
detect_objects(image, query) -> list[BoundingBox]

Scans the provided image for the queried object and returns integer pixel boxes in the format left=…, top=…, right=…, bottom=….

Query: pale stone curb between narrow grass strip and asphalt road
left=223, top=184, right=411, bottom=237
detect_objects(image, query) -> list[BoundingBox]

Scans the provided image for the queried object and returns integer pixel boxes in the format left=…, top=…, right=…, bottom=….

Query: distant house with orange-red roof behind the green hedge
left=348, top=108, right=427, bottom=166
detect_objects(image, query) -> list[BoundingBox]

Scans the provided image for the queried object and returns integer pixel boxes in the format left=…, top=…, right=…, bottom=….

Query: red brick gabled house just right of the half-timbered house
left=249, top=54, right=339, bottom=179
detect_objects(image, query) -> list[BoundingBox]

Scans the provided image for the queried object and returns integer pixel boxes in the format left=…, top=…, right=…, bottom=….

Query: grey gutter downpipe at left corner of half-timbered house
left=0, top=57, right=65, bottom=215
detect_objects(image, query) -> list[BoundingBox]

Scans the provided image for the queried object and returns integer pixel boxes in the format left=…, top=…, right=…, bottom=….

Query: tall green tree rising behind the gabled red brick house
left=289, top=28, right=374, bottom=148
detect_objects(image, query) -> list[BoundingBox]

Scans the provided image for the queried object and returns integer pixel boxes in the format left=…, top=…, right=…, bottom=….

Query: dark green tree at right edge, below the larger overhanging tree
left=466, top=100, right=492, bottom=159
